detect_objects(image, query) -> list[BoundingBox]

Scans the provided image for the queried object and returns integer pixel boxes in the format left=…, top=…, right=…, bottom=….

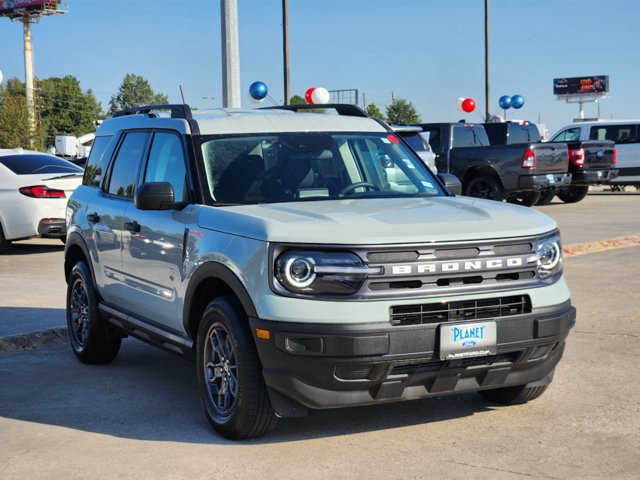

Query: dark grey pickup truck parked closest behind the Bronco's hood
left=419, top=122, right=571, bottom=206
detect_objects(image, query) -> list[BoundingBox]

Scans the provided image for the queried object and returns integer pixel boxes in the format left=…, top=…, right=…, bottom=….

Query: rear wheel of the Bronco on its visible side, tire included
left=67, top=260, right=122, bottom=364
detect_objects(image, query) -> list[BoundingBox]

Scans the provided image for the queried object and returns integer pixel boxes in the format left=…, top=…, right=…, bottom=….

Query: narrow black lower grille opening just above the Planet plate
left=389, top=295, right=531, bottom=326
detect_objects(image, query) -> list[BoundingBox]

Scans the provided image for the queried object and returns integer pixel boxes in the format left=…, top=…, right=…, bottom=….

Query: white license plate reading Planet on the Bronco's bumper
left=440, top=322, right=496, bottom=360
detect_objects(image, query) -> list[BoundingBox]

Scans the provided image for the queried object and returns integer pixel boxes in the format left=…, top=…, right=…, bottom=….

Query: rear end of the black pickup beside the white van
left=536, top=130, right=618, bottom=205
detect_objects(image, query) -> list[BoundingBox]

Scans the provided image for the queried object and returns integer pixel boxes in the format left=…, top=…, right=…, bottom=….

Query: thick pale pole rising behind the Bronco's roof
left=220, top=0, right=241, bottom=108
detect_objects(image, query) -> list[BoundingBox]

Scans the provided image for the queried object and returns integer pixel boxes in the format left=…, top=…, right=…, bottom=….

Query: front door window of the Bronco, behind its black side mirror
left=144, top=133, right=188, bottom=203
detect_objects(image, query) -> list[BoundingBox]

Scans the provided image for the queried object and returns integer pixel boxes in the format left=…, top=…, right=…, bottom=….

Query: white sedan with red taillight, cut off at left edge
left=0, top=149, right=84, bottom=252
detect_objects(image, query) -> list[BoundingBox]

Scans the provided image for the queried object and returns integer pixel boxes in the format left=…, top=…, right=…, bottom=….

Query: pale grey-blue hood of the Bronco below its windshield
left=199, top=197, right=556, bottom=245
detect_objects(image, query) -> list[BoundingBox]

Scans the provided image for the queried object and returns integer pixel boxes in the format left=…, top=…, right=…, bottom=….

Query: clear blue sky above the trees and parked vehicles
left=0, top=0, right=640, bottom=133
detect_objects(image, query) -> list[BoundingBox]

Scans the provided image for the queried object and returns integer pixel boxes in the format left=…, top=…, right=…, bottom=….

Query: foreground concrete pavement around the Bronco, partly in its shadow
left=0, top=247, right=640, bottom=480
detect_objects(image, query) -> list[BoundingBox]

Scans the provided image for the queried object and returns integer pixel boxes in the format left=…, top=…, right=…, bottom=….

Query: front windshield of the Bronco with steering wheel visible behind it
left=197, top=132, right=445, bottom=204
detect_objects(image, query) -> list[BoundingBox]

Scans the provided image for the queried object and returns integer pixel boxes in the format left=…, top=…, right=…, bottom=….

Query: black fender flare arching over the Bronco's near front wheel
left=182, top=261, right=258, bottom=338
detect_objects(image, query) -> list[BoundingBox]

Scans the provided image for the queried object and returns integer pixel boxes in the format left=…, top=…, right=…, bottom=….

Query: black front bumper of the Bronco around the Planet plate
left=250, top=302, right=575, bottom=417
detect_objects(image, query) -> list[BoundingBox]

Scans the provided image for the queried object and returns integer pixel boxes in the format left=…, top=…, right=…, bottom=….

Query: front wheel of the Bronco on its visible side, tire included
left=196, top=296, right=277, bottom=440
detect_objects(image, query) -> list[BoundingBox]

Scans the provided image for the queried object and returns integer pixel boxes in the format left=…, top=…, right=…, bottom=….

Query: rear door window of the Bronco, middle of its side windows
left=108, top=132, right=149, bottom=198
